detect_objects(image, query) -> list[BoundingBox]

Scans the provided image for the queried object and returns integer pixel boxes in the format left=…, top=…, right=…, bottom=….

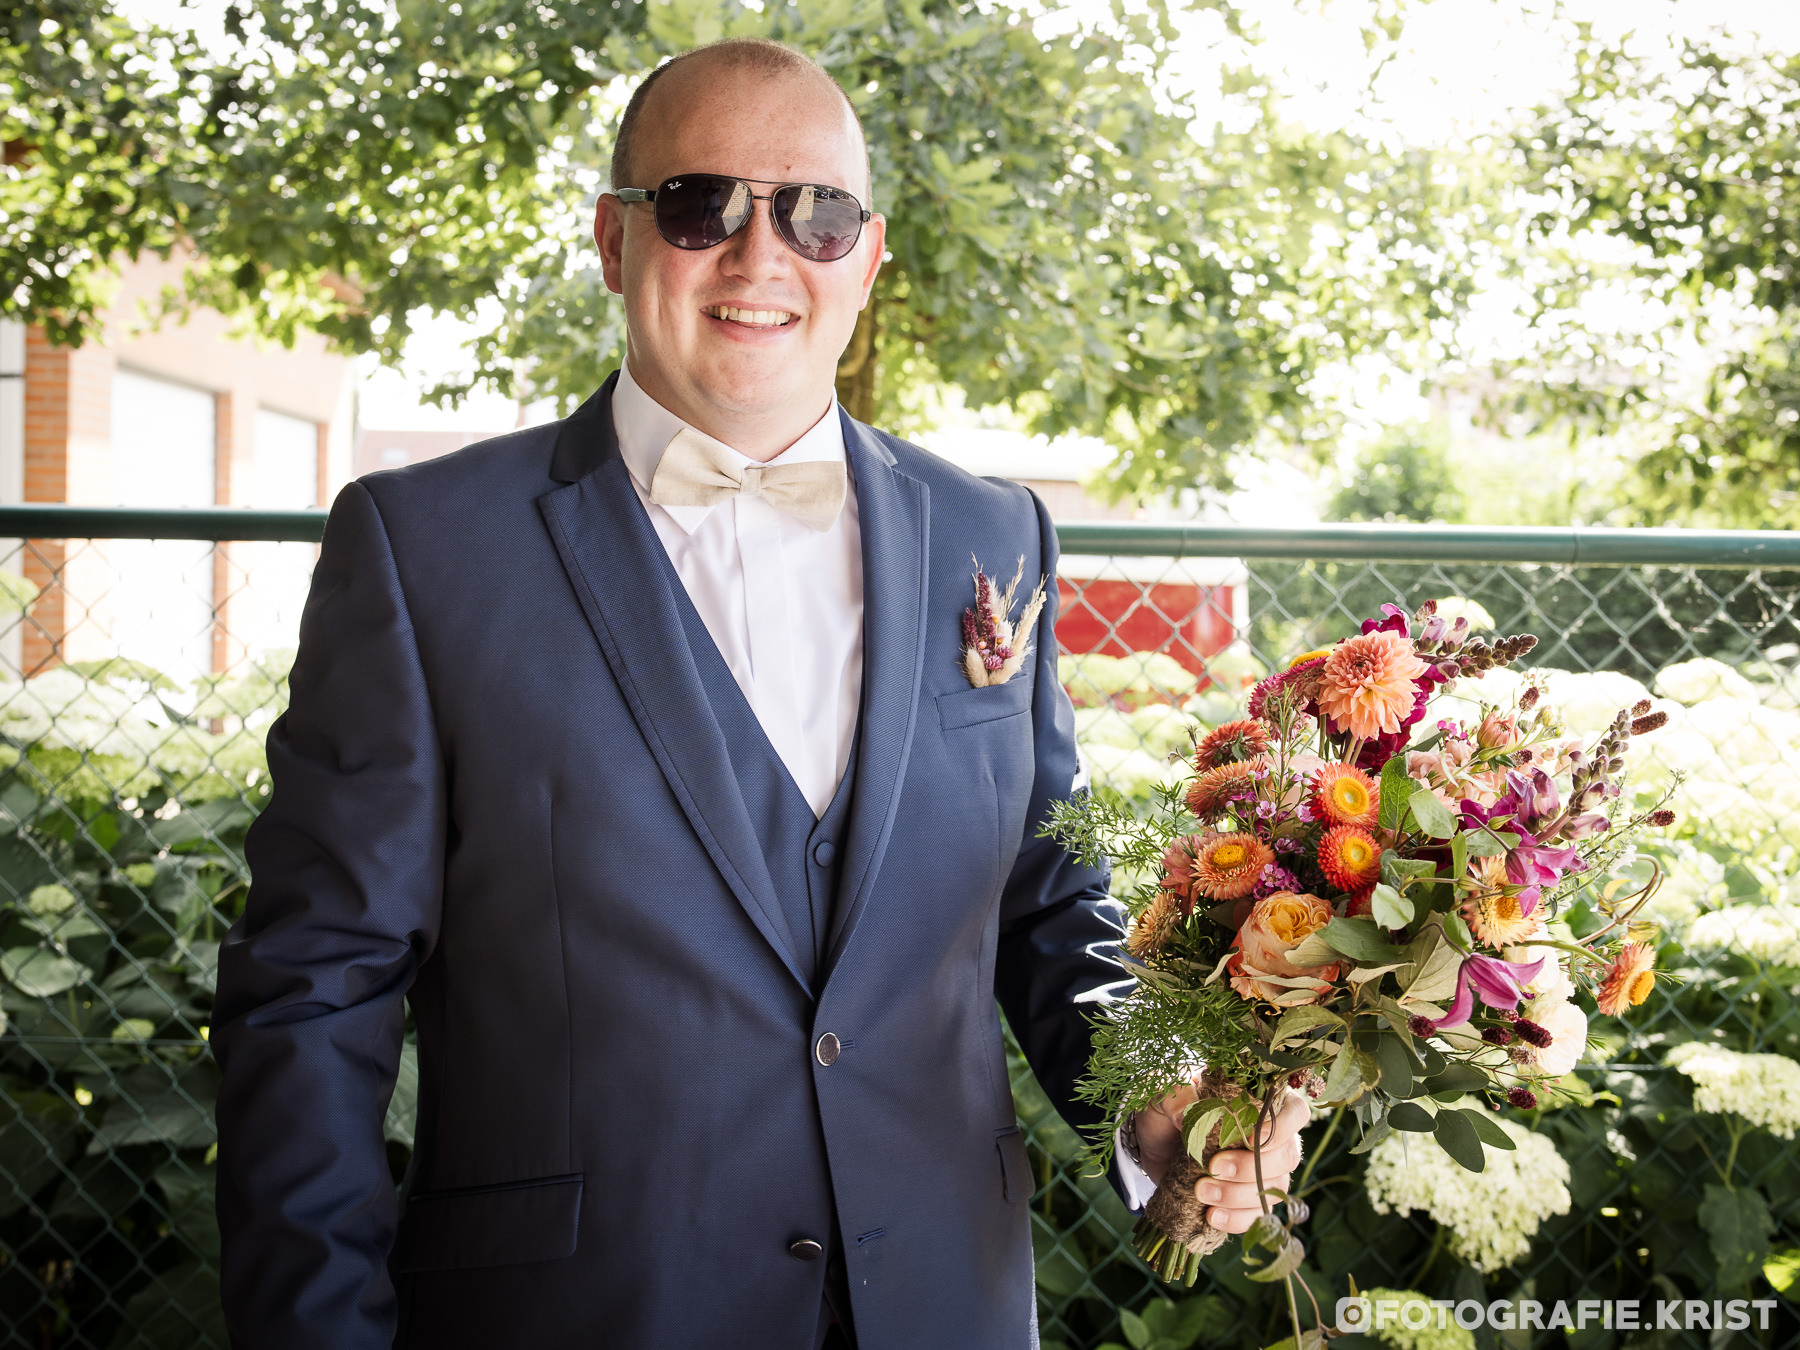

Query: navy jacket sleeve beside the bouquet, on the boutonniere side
left=995, top=497, right=1130, bottom=1184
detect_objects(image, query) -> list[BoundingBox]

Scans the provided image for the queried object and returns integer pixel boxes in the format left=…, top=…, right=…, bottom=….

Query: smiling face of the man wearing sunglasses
left=594, top=61, right=886, bottom=457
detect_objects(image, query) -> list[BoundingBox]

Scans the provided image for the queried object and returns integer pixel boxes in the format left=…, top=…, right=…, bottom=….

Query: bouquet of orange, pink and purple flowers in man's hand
left=1048, top=601, right=1674, bottom=1310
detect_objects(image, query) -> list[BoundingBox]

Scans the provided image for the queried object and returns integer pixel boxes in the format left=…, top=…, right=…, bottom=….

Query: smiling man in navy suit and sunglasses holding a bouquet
left=212, top=43, right=1292, bottom=1350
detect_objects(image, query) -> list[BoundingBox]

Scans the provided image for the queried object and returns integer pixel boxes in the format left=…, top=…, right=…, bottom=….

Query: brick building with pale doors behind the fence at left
left=0, top=257, right=355, bottom=675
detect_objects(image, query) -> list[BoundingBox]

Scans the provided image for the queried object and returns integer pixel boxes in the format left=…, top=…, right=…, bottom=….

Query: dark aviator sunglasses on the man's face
left=617, top=173, right=871, bottom=263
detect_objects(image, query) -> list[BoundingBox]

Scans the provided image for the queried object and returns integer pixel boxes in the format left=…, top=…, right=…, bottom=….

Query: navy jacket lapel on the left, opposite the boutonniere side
left=538, top=380, right=810, bottom=992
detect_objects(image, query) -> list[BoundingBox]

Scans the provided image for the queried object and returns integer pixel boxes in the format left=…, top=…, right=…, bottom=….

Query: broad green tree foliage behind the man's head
left=0, top=0, right=1465, bottom=493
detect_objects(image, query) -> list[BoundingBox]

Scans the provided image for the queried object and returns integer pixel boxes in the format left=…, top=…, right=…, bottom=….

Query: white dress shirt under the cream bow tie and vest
left=612, top=367, right=862, bottom=815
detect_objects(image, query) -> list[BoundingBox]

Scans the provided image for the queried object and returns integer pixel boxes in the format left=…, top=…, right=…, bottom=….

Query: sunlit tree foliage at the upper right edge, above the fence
left=1521, top=36, right=1800, bottom=526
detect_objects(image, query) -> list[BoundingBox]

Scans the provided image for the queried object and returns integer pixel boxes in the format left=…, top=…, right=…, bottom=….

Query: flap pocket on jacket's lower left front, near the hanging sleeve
left=394, top=1172, right=581, bottom=1274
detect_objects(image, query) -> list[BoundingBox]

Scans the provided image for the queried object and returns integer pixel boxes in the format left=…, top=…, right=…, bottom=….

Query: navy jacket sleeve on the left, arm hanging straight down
left=212, top=484, right=445, bottom=1350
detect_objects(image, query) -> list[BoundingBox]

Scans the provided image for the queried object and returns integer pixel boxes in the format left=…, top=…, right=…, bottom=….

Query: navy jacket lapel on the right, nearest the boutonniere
left=824, top=414, right=931, bottom=974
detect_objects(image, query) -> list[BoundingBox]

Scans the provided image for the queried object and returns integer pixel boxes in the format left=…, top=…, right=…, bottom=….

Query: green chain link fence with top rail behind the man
left=0, top=508, right=1800, bottom=1350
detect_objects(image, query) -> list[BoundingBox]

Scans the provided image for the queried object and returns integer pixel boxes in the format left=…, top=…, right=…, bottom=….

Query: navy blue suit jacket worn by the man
left=212, top=385, right=1120, bottom=1350
